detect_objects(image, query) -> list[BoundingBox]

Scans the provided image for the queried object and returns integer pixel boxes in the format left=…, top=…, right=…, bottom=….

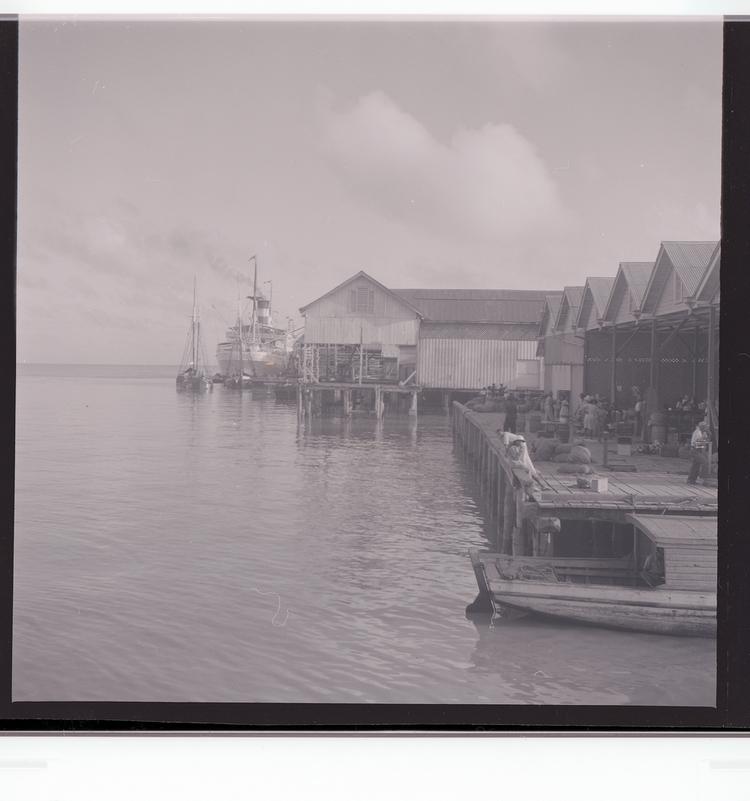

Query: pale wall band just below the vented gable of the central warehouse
left=305, top=316, right=419, bottom=345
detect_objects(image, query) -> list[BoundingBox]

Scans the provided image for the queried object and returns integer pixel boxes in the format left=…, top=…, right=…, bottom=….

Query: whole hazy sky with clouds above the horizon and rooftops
left=17, top=19, right=722, bottom=364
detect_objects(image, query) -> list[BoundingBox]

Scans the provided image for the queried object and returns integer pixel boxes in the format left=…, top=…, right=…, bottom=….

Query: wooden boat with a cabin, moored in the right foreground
left=467, top=514, right=717, bottom=637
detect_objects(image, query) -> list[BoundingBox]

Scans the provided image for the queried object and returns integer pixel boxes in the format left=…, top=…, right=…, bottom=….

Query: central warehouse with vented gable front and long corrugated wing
left=300, top=272, right=548, bottom=392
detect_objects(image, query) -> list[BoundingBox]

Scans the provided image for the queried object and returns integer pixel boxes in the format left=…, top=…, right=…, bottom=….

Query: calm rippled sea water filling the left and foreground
left=13, top=366, right=715, bottom=706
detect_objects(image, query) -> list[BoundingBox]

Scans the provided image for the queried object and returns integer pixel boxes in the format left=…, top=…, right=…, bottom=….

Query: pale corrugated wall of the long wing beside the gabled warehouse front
left=417, top=339, right=536, bottom=389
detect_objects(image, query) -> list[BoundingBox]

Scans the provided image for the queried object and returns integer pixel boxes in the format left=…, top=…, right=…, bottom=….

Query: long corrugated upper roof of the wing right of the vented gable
left=393, top=289, right=547, bottom=324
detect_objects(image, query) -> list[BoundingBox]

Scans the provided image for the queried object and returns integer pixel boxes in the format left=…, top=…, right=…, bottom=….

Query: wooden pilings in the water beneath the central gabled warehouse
left=297, top=382, right=420, bottom=420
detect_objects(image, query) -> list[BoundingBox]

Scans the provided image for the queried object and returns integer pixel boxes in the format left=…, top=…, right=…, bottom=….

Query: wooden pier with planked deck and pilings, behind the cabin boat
left=451, top=402, right=718, bottom=556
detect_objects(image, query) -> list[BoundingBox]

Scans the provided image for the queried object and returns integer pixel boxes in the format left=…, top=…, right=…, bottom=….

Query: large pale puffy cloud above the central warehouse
left=321, top=92, right=566, bottom=241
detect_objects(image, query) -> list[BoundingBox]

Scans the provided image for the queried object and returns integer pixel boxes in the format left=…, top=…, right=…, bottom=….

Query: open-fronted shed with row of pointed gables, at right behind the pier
left=584, top=242, right=720, bottom=439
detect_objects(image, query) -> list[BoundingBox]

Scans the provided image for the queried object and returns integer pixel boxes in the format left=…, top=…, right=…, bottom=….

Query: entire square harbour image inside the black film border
left=13, top=19, right=722, bottom=707
